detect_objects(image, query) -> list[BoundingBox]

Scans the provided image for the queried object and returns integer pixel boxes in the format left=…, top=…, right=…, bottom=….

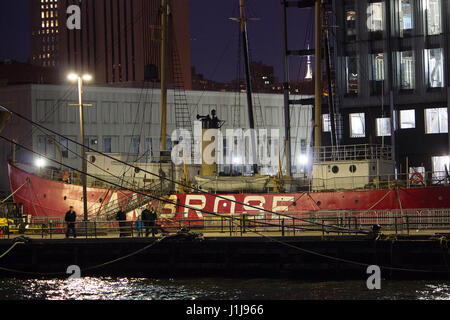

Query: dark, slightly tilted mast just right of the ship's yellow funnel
left=239, top=0, right=258, bottom=174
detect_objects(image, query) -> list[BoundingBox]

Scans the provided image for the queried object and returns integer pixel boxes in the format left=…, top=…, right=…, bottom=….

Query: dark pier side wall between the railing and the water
left=0, top=233, right=450, bottom=279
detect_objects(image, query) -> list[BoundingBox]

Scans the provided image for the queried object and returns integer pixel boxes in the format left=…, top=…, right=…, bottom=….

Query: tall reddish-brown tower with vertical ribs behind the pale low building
left=30, top=0, right=191, bottom=89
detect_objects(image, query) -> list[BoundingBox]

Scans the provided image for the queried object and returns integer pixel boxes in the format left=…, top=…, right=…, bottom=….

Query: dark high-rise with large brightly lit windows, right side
left=323, top=0, right=450, bottom=179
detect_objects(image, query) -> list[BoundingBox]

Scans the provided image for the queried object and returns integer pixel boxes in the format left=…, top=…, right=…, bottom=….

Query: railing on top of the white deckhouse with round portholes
left=314, top=144, right=392, bottom=162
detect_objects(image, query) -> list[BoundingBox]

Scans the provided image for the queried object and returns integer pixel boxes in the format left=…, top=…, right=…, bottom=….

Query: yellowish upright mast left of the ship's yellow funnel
left=160, top=0, right=168, bottom=160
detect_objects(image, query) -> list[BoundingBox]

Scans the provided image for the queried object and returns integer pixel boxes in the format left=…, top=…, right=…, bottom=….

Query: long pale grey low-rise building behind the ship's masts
left=0, top=85, right=312, bottom=190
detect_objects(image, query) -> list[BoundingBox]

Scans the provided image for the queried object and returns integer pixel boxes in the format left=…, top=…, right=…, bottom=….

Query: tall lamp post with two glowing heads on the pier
left=67, top=73, right=92, bottom=221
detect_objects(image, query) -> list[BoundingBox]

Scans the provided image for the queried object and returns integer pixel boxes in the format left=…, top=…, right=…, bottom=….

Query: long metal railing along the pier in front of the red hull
left=1, top=208, right=450, bottom=238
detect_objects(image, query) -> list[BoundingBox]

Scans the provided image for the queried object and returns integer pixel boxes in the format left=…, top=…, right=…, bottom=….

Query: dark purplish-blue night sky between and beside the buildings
left=0, top=0, right=313, bottom=82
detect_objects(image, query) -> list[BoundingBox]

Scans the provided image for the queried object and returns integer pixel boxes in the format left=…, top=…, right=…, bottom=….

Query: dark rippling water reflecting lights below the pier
left=0, top=278, right=450, bottom=301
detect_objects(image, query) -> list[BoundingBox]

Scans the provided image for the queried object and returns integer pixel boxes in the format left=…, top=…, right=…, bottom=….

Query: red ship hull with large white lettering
left=8, top=164, right=450, bottom=221
